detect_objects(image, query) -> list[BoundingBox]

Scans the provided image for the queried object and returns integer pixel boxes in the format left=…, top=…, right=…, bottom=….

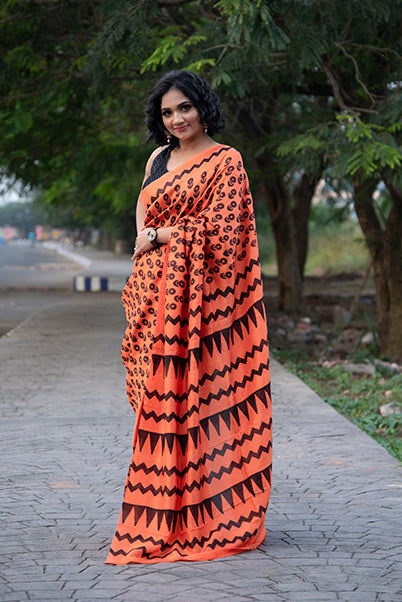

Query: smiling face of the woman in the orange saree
left=161, top=88, right=205, bottom=142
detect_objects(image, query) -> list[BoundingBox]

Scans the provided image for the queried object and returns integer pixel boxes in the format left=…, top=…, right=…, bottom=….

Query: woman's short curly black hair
left=145, top=71, right=225, bottom=146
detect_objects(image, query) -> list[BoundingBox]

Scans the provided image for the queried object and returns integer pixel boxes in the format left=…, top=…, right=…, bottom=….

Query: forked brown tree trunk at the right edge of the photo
left=354, top=180, right=402, bottom=361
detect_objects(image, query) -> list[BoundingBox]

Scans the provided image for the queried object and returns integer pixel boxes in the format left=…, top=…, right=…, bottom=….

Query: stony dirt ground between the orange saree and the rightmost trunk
left=264, top=273, right=376, bottom=358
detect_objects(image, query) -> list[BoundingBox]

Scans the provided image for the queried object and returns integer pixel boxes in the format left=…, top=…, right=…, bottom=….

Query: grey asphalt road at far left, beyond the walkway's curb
left=0, top=241, right=82, bottom=336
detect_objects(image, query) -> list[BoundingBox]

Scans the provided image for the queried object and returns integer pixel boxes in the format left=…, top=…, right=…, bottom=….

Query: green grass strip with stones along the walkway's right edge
left=275, top=351, right=402, bottom=462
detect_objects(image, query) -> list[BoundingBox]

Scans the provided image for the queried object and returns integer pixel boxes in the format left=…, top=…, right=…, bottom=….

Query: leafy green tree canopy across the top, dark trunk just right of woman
left=0, top=0, right=402, bottom=338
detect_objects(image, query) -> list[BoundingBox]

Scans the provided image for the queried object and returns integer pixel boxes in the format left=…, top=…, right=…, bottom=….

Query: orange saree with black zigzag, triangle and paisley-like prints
left=106, top=145, right=272, bottom=564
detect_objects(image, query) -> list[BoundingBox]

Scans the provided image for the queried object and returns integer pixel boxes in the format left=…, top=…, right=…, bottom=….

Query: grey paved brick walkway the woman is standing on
left=0, top=293, right=402, bottom=602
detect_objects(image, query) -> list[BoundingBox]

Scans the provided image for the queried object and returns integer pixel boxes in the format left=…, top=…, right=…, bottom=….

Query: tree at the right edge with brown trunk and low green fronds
left=279, top=115, right=402, bottom=360
